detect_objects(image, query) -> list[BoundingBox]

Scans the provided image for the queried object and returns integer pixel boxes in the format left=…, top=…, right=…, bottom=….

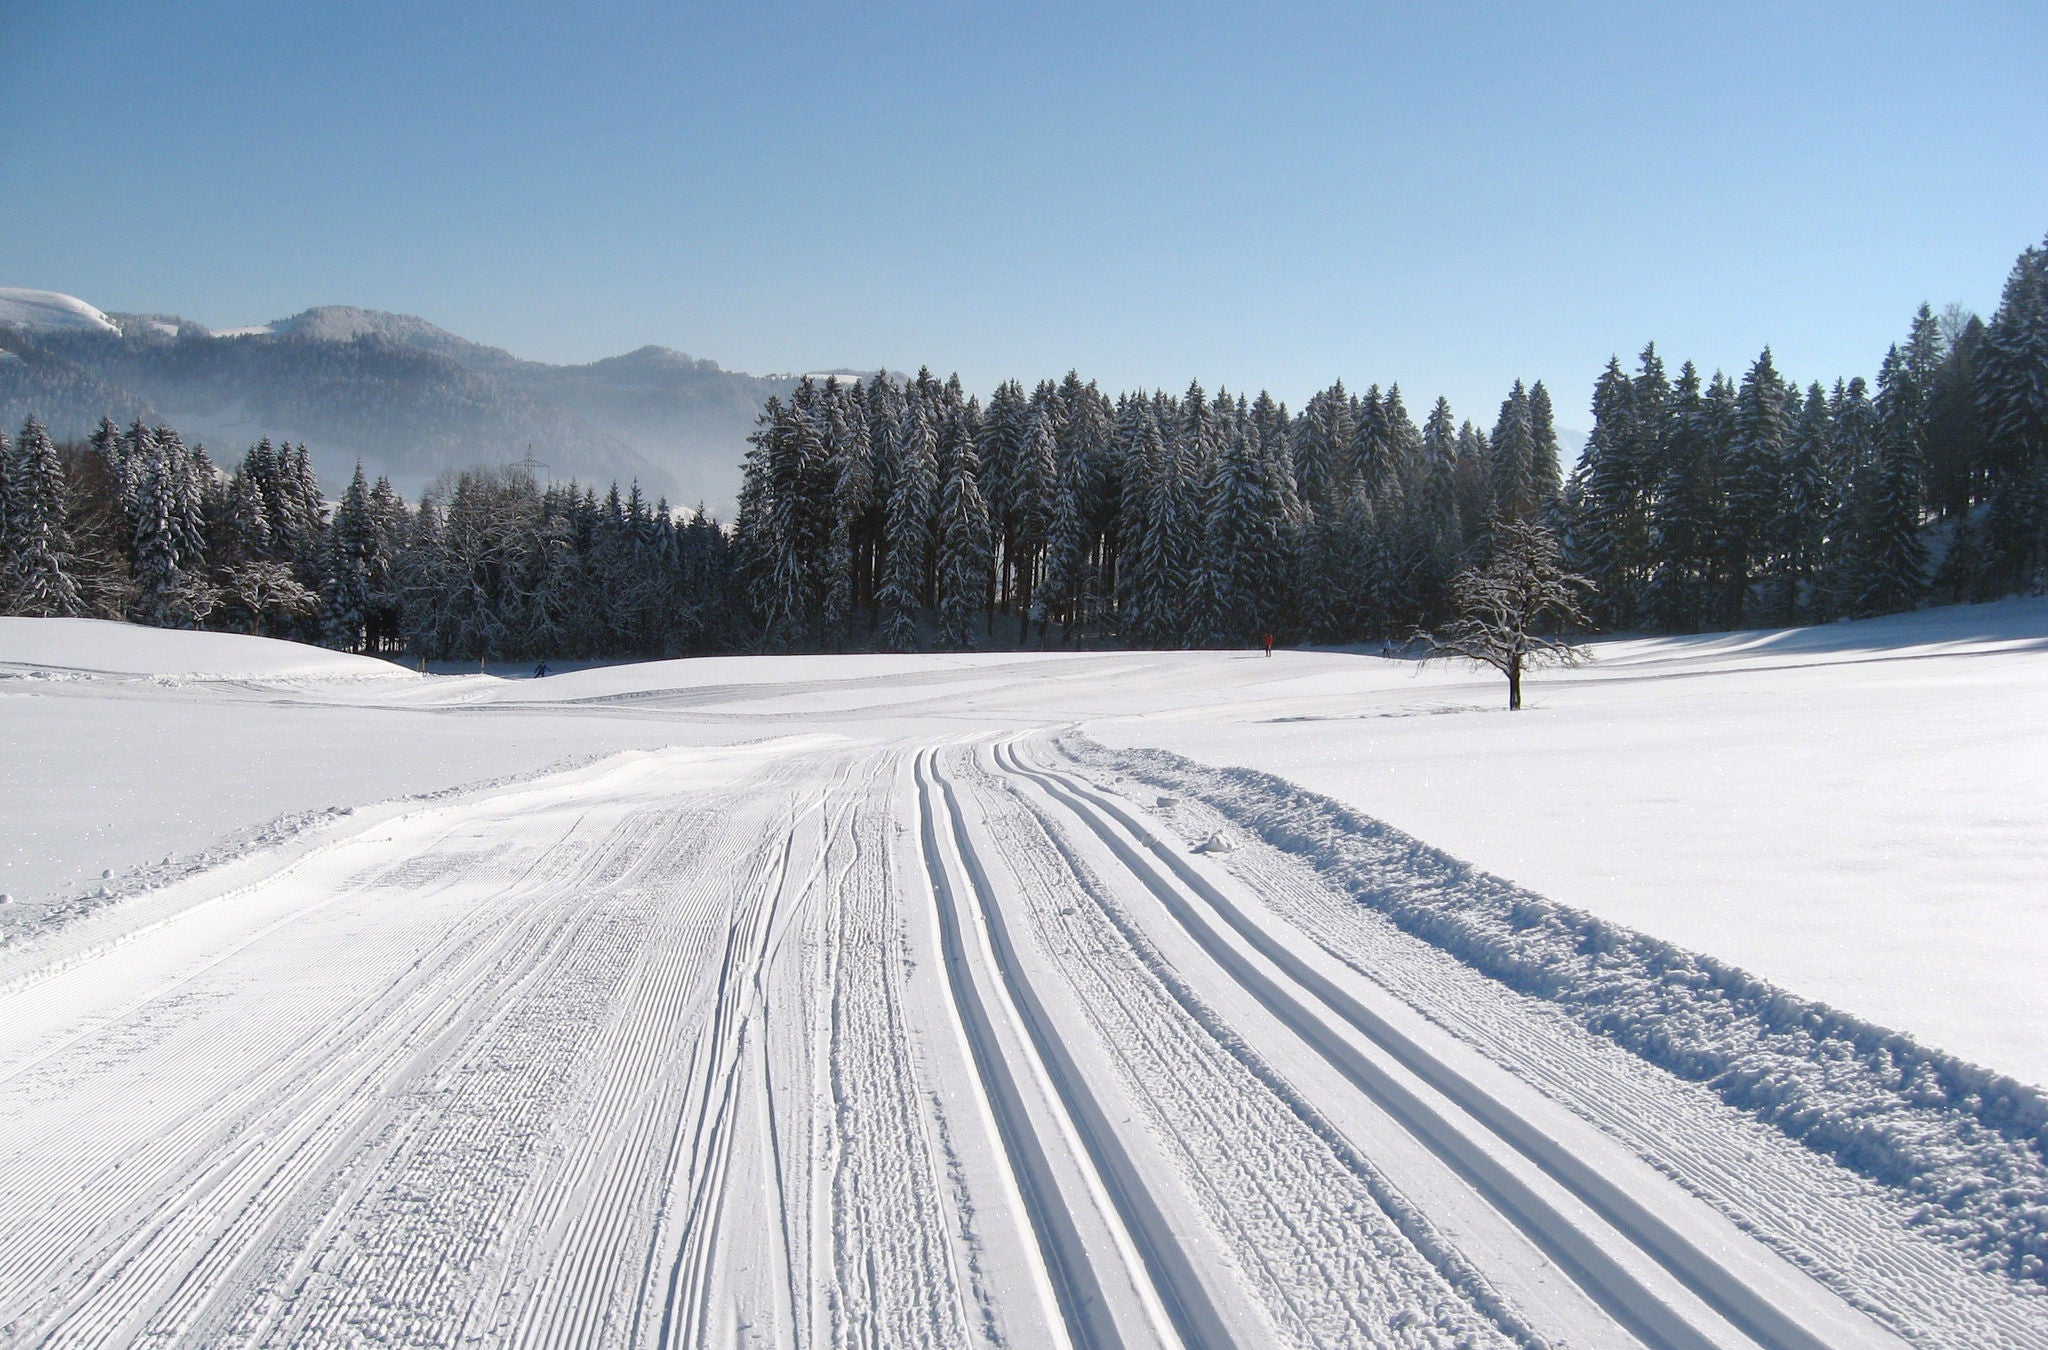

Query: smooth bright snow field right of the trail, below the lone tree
left=1092, top=600, right=2048, bottom=1084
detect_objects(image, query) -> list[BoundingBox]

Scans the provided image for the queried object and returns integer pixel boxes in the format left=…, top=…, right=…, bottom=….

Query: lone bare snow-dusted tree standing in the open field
left=1421, top=520, right=1591, bottom=711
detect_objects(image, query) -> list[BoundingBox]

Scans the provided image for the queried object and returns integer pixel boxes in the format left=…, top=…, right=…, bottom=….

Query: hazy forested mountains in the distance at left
left=0, top=291, right=795, bottom=518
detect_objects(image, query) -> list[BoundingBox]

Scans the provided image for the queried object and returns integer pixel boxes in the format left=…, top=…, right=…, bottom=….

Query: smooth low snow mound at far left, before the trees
left=0, top=619, right=418, bottom=680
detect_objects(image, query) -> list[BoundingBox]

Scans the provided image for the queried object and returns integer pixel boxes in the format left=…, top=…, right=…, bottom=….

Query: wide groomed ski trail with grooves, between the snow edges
left=0, top=618, right=2048, bottom=1350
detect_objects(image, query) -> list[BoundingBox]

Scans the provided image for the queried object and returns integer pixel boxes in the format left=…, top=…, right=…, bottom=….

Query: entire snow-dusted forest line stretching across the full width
left=0, top=229, right=2048, bottom=660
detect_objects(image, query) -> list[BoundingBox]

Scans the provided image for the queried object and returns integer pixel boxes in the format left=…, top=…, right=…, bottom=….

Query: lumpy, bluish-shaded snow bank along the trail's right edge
left=1059, top=733, right=2048, bottom=1284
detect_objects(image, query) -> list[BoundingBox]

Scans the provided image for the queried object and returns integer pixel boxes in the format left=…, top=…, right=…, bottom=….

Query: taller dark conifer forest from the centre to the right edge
left=733, top=229, right=2048, bottom=651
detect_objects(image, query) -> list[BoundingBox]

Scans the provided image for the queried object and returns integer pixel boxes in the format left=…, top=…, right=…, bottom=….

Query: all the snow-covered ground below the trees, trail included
left=0, top=614, right=2048, bottom=1346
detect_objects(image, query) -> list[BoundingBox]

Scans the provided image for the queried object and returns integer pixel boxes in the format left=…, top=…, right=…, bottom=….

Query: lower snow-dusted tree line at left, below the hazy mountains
left=0, top=418, right=741, bottom=660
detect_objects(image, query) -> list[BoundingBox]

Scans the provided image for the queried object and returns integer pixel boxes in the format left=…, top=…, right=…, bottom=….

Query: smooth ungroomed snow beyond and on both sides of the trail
left=0, top=600, right=2048, bottom=1084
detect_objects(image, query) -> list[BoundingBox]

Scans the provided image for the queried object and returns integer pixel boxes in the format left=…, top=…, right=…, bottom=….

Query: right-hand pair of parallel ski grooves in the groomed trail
left=997, top=748, right=1888, bottom=1348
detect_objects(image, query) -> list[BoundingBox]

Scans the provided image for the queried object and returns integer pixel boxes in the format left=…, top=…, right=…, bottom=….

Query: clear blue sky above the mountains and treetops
left=0, top=0, right=2048, bottom=426
